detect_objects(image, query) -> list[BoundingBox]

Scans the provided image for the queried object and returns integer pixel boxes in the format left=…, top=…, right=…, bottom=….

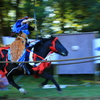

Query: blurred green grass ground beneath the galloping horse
left=0, top=75, right=100, bottom=100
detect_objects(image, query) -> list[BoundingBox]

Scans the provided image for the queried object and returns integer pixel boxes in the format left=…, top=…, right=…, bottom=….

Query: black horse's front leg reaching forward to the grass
left=40, top=72, right=61, bottom=93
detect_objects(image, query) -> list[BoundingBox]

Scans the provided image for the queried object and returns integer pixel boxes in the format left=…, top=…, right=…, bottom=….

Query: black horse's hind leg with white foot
left=7, top=75, right=27, bottom=94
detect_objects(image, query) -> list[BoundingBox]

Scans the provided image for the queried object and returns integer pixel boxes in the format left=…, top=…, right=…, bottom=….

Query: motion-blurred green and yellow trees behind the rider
left=0, top=0, right=100, bottom=37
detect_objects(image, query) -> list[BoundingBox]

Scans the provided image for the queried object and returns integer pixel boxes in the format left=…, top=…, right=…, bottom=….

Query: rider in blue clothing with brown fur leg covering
left=10, top=16, right=35, bottom=61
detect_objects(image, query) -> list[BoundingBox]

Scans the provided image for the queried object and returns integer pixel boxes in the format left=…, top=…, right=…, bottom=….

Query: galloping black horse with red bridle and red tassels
left=0, top=37, right=68, bottom=94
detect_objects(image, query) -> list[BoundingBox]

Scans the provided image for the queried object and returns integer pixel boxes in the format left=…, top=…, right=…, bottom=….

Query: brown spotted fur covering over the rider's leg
left=10, top=33, right=27, bottom=61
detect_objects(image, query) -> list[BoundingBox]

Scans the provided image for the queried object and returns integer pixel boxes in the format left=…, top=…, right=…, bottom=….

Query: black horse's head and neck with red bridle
left=34, top=37, right=68, bottom=56
